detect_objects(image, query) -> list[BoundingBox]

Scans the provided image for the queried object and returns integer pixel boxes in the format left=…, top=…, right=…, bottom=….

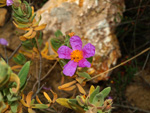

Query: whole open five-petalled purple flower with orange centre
left=57, top=36, right=95, bottom=76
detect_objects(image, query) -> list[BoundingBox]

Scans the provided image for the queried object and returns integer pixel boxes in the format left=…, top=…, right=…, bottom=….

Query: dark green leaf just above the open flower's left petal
left=50, top=38, right=62, bottom=51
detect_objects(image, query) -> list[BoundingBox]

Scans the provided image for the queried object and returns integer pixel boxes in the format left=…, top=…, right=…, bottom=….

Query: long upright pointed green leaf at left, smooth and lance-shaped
left=18, top=61, right=30, bottom=89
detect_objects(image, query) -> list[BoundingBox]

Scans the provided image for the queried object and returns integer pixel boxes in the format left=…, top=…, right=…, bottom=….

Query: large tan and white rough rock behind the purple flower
left=36, top=0, right=125, bottom=82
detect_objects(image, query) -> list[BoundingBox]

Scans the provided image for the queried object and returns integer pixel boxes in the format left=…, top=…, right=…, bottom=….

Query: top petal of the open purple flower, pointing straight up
left=70, top=36, right=82, bottom=50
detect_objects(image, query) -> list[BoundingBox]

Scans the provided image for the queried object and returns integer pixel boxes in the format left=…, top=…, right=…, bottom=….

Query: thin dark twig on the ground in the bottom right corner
left=113, top=104, right=150, bottom=113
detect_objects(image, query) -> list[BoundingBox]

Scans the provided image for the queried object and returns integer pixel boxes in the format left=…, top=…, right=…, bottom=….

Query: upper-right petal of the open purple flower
left=82, top=43, right=95, bottom=58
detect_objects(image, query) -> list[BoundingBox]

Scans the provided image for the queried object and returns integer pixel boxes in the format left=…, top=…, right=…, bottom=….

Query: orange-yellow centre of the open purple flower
left=71, top=50, right=83, bottom=62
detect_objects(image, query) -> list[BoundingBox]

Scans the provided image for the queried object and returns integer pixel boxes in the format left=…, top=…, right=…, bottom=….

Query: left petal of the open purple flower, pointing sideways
left=57, top=46, right=72, bottom=59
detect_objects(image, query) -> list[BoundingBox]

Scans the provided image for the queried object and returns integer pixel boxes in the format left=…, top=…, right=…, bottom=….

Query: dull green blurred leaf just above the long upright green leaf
left=13, top=53, right=26, bottom=65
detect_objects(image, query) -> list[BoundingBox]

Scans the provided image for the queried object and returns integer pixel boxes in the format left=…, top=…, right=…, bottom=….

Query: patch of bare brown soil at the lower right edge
left=126, top=69, right=150, bottom=111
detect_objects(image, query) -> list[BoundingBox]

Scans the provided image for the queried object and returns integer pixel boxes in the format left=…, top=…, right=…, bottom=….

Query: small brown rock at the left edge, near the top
left=0, top=8, right=7, bottom=27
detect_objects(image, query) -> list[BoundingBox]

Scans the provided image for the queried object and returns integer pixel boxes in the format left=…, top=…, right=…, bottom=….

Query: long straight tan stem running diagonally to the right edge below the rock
left=87, top=47, right=150, bottom=81
